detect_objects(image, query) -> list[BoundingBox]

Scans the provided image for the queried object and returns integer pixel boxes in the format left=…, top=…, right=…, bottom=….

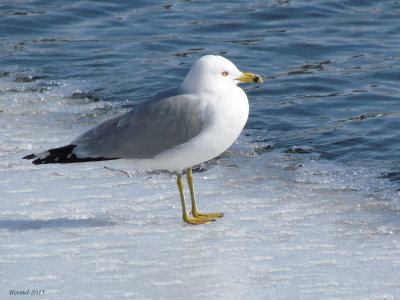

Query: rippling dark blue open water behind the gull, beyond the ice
left=0, top=1, right=400, bottom=182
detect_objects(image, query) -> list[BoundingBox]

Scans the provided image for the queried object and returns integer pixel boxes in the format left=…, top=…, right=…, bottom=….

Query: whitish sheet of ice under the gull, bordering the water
left=0, top=71, right=400, bottom=299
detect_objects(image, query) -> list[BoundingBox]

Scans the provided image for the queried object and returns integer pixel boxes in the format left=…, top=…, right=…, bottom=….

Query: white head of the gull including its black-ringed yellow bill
left=182, top=55, right=262, bottom=93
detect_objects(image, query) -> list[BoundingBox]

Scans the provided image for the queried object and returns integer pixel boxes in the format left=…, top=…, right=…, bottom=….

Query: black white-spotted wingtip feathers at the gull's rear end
left=23, top=145, right=116, bottom=165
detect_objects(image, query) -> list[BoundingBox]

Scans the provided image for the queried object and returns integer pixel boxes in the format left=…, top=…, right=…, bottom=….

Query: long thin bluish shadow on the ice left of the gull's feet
left=0, top=218, right=116, bottom=231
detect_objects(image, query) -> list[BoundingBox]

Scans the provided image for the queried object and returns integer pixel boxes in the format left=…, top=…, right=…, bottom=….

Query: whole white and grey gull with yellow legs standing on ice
left=24, top=55, right=262, bottom=224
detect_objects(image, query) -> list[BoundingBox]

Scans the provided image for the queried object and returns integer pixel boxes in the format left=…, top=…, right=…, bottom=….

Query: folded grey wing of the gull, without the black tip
left=71, top=88, right=207, bottom=159
